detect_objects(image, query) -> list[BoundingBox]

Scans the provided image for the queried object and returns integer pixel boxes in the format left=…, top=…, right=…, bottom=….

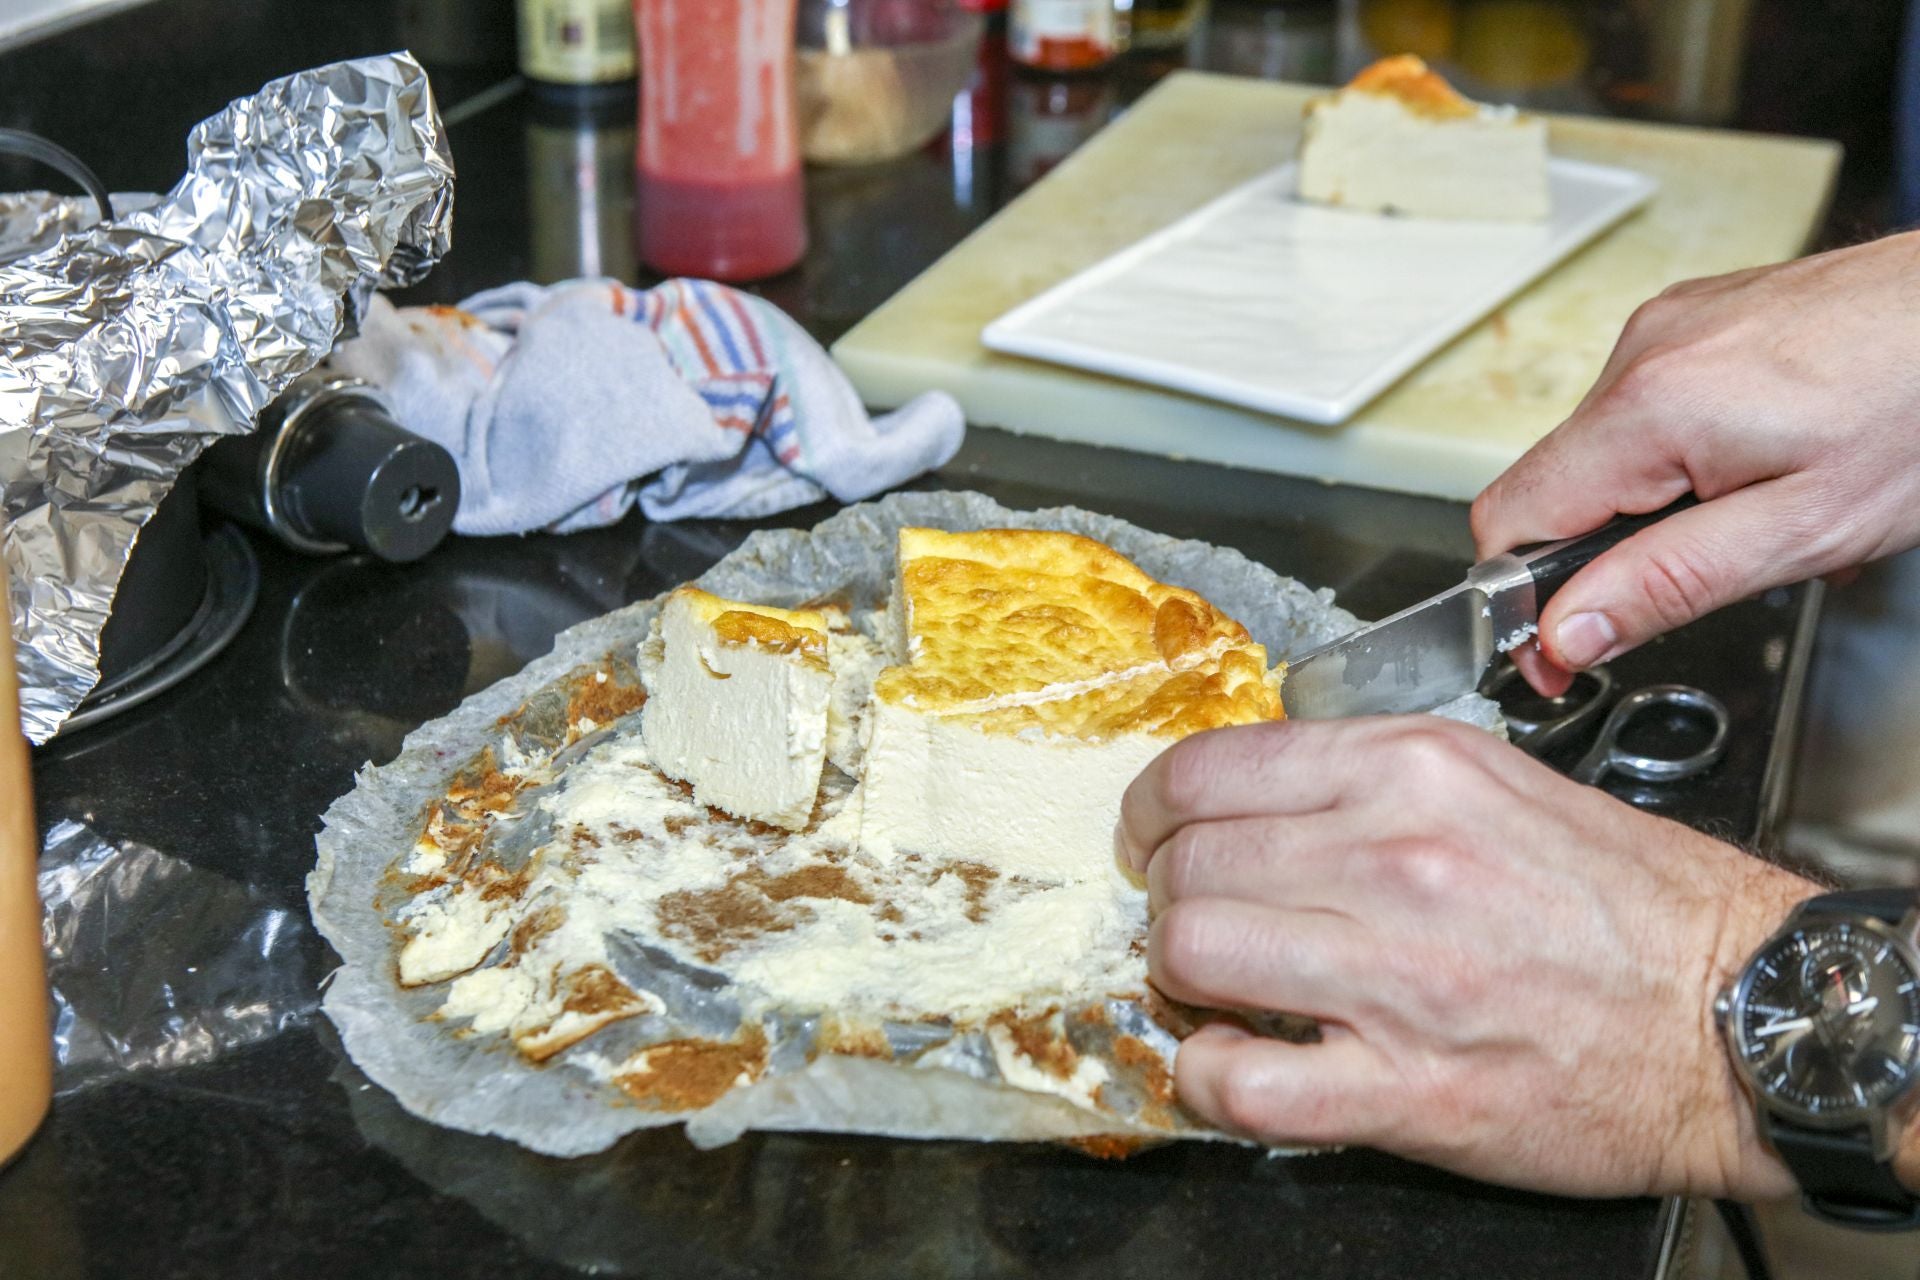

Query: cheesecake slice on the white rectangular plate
left=1300, top=54, right=1551, bottom=221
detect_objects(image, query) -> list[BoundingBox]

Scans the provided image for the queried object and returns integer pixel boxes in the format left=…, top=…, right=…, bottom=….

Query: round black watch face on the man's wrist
left=1732, top=921, right=1920, bottom=1125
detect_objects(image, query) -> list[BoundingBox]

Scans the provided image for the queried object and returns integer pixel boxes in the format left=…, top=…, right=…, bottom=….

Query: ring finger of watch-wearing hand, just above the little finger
left=1146, top=898, right=1379, bottom=1019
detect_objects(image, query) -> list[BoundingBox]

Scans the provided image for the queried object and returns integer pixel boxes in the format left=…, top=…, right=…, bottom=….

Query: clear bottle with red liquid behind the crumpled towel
left=634, top=0, right=806, bottom=280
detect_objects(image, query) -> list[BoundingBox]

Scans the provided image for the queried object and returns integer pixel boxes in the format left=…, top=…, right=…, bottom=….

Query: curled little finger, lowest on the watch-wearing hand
left=1173, top=1027, right=1407, bottom=1146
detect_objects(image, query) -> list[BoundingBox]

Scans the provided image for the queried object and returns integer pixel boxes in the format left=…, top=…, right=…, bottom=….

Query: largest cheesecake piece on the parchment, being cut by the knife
left=860, top=528, right=1281, bottom=885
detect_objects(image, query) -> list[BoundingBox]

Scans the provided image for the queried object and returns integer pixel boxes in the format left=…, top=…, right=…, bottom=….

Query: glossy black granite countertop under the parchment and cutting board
left=0, top=0, right=1876, bottom=1280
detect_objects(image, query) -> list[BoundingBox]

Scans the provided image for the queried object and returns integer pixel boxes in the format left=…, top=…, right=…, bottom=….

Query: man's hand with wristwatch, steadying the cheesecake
left=1119, top=716, right=1816, bottom=1197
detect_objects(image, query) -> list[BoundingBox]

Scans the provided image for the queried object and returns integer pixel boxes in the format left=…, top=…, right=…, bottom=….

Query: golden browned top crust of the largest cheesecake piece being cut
left=874, top=528, right=1281, bottom=739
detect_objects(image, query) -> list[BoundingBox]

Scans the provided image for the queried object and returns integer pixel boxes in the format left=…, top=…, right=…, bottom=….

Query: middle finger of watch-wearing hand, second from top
left=1146, top=810, right=1375, bottom=913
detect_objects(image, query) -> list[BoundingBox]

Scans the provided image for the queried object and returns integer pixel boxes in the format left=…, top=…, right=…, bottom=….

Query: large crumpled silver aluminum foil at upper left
left=0, top=54, right=453, bottom=743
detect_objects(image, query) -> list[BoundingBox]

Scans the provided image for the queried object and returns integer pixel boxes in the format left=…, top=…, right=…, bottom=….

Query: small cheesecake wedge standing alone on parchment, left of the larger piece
left=639, top=587, right=833, bottom=831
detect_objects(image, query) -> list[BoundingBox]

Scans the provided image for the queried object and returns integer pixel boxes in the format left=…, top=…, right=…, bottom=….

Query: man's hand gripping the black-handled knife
left=1473, top=232, right=1920, bottom=693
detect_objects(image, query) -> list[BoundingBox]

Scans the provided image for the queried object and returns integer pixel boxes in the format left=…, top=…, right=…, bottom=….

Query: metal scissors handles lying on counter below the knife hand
left=1480, top=662, right=1732, bottom=785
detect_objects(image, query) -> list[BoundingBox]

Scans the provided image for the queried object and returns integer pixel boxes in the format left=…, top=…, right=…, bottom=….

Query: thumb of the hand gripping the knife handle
left=1540, top=480, right=1822, bottom=672
